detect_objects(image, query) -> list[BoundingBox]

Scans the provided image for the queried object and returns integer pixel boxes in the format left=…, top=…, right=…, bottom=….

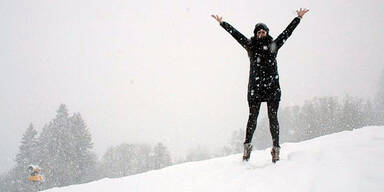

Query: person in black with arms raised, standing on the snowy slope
left=212, top=8, right=309, bottom=163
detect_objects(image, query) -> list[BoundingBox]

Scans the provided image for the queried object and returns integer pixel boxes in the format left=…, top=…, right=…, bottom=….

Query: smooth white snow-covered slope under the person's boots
left=48, top=127, right=384, bottom=192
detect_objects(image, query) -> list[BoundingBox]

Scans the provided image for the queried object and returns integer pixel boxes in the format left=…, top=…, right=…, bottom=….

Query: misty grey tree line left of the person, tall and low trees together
left=0, top=104, right=172, bottom=192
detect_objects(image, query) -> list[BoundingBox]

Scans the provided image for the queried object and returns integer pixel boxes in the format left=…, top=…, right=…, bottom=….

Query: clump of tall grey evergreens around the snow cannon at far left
left=0, top=105, right=100, bottom=192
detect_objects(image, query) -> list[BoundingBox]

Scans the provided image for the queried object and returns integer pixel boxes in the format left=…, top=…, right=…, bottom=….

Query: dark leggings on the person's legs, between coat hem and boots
left=244, top=101, right=280, bottom=147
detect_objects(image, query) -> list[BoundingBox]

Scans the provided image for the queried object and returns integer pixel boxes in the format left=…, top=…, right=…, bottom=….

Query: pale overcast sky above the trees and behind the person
left=0, top=0, right=384, bottom=173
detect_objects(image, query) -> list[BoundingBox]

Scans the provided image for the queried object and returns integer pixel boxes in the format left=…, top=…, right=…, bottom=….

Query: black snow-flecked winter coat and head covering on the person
left=220, top=17, right=300, bottom=105
